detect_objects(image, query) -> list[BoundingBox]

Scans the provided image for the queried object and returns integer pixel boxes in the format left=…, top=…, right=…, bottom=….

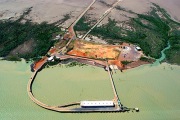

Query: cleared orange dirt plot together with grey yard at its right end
left=65, top=40, right=144, bottom=70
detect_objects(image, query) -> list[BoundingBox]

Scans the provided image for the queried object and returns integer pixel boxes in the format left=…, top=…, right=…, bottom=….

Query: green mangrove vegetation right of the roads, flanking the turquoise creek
left=76, top=4, right=180, bottom=64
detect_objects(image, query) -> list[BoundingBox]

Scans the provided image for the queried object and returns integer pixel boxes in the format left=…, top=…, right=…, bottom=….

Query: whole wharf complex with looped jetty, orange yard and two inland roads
left=27, top=0, right=143, bottom=113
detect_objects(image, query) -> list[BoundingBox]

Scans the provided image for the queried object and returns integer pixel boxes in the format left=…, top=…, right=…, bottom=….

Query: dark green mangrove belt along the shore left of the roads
left=0, top=8, right=60, bottom=59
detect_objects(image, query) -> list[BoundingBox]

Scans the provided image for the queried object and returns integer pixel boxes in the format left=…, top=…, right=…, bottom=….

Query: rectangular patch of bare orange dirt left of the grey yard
left=67, top=40, right=121, bottom=59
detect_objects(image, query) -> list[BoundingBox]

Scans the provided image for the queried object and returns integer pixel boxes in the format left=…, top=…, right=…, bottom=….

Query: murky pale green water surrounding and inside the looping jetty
left=0, top=61, right=180, bottom=120
